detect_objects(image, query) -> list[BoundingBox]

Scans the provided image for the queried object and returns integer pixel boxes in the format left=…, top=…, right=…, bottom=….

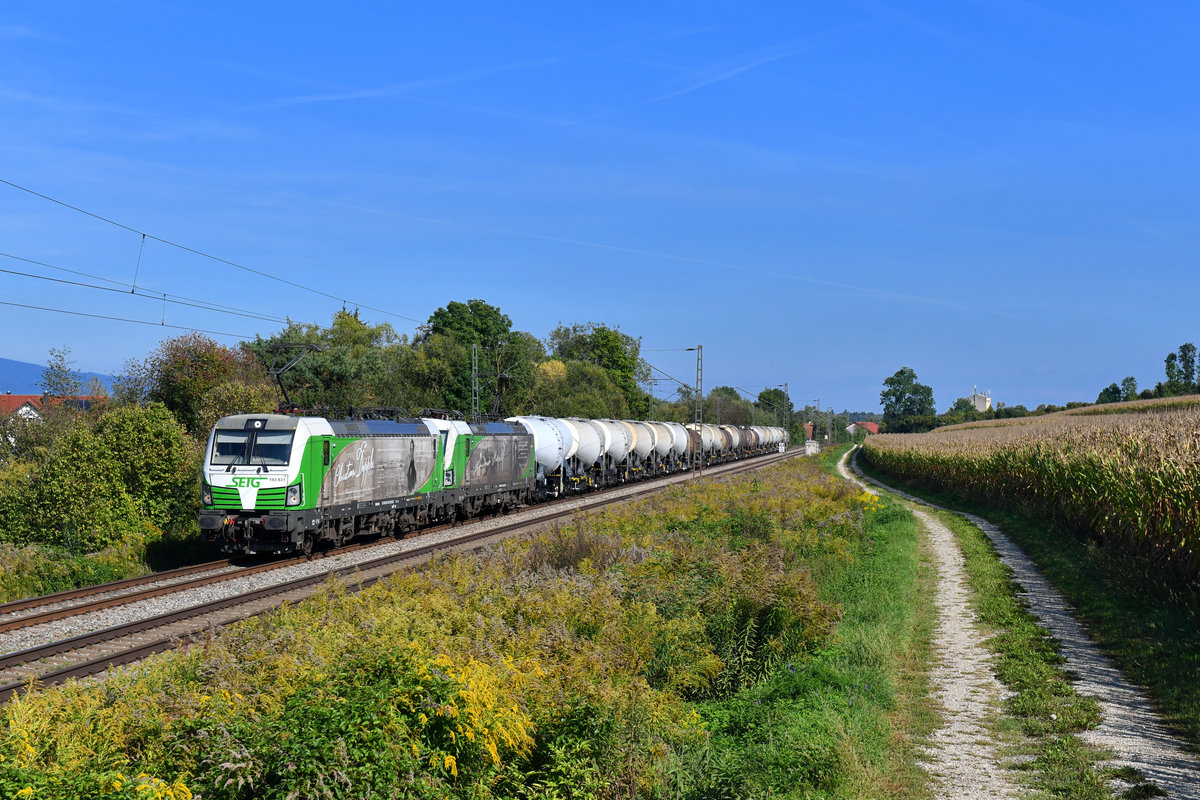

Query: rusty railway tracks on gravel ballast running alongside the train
left=0, top=451, right=803, bottom=703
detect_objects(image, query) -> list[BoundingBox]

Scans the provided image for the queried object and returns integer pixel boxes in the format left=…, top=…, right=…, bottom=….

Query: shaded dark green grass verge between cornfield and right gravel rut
left=859, top=453, right=1200, bottom=752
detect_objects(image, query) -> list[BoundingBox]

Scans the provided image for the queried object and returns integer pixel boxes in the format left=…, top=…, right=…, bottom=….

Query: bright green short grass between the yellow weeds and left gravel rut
left=701, top=470, right=937, bottom=798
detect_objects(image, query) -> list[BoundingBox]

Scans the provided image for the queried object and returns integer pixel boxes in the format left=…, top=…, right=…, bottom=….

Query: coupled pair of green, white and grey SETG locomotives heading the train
left=199, top=414, right=538, bottom=553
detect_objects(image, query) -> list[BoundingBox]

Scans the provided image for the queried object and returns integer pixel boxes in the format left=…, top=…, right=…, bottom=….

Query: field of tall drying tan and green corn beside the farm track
left=863, top=405, right=1200, bottom=585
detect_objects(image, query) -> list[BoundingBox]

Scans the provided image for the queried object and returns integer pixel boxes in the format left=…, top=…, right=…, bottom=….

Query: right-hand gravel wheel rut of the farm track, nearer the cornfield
left=854, top=450, right=1200, bottom=800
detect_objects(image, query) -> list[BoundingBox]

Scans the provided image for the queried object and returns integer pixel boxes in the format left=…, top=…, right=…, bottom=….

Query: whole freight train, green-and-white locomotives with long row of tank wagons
left=199, top=413, right=788, bottom=554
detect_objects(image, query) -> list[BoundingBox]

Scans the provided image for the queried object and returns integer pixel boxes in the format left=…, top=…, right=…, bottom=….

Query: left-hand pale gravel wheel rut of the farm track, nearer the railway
left=838, top=458, right=1021, bottom=800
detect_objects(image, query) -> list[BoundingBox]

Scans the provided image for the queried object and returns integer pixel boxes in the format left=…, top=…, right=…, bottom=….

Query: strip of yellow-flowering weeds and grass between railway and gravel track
left=0, top=459, right=931, bottom=799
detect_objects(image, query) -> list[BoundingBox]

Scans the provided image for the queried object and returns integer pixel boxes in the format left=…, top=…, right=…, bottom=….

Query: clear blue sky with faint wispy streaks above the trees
left=0, top=0, right=1200, bottom=410
